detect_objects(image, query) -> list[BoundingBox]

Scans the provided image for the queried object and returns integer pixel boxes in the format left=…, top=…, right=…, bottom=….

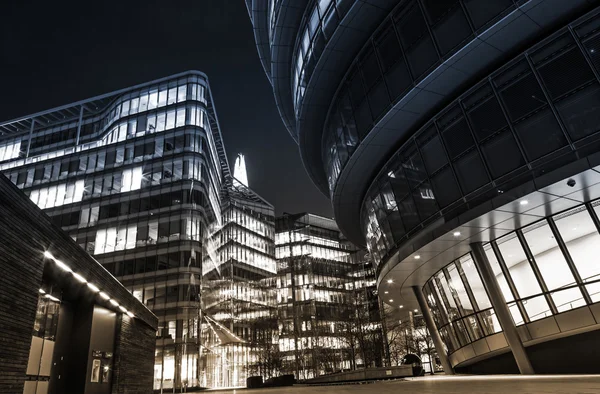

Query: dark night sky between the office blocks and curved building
left=0, top=0, right=331, bottom=216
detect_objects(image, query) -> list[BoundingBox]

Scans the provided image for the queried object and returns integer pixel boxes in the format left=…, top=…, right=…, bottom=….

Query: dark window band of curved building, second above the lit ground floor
left=324, top=0, right=522, bottom=193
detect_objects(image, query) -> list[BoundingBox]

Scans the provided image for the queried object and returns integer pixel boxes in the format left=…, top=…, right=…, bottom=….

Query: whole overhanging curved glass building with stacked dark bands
left=251, top=0, right=600, bottom=373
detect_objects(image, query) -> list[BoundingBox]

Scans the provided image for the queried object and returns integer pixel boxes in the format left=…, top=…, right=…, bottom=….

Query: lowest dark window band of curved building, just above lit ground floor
left=360, top=12, right=600, bottom=266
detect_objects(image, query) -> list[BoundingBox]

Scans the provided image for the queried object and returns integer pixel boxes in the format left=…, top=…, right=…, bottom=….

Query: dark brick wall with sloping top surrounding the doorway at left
left=0, top=174, right=158, bottom=394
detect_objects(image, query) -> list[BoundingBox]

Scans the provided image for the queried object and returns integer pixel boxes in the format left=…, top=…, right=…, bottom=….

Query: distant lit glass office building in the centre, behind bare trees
left=275, top=213, right=384, bottom=379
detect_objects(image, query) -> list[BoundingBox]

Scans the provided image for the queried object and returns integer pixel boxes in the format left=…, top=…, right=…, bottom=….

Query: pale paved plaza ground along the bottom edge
left=213, top=375, right=600, bottom=394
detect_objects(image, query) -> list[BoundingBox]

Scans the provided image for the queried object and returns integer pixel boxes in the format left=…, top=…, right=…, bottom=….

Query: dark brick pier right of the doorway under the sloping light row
left=112, top=315, right=156, bottom=394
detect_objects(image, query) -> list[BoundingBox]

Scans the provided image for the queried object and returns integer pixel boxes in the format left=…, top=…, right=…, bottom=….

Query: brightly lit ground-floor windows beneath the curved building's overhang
left=423, top=200, right=600, bottom=353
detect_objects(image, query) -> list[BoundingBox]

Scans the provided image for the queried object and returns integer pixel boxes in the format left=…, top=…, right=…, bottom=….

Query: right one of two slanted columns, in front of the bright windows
left=470, top=242, right=535, bottom=375
